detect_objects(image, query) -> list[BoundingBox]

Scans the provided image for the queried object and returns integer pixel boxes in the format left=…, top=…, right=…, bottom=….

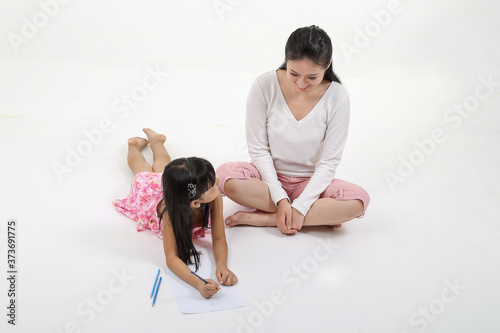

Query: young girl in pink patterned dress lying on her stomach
left=113, top=128, right=238, bottom=298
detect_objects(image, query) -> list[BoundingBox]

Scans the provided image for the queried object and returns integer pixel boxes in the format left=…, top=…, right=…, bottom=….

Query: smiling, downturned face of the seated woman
left=286, top=58, right=325, bottom=92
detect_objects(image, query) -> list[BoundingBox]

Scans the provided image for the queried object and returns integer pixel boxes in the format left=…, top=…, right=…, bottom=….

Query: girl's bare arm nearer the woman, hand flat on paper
left=211, top=193, right=238, bottom=286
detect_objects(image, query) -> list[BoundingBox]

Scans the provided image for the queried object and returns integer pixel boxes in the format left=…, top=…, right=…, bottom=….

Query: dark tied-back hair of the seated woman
left=279, top=25, right=341, bottom=83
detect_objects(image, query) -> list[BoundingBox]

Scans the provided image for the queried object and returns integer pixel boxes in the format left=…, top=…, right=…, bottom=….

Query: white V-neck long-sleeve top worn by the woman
left=246, top=70, right=350, bottom=216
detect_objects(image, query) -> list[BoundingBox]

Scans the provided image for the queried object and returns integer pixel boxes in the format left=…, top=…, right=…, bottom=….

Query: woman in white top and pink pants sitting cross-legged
left=217, top=26, right=370, bottom=234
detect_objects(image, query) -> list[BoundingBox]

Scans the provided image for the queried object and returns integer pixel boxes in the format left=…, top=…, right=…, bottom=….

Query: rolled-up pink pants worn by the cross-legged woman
left=216, top=162, right=370, bottom=218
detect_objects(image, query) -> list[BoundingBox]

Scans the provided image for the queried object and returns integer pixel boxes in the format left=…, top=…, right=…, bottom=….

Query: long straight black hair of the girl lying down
left=157, top=157, right=215, bottom=271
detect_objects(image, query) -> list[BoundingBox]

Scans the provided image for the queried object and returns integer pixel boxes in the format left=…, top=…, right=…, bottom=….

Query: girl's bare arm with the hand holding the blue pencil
left=163, top=214, right=220, bottom=298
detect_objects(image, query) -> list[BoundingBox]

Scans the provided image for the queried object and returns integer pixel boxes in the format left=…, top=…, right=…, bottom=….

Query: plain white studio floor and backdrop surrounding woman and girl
left=0, top=0, right=500, bottom=333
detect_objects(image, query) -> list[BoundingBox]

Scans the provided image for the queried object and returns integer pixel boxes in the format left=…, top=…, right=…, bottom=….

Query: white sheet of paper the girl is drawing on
left=162, top=251, right=245, bottom=313
